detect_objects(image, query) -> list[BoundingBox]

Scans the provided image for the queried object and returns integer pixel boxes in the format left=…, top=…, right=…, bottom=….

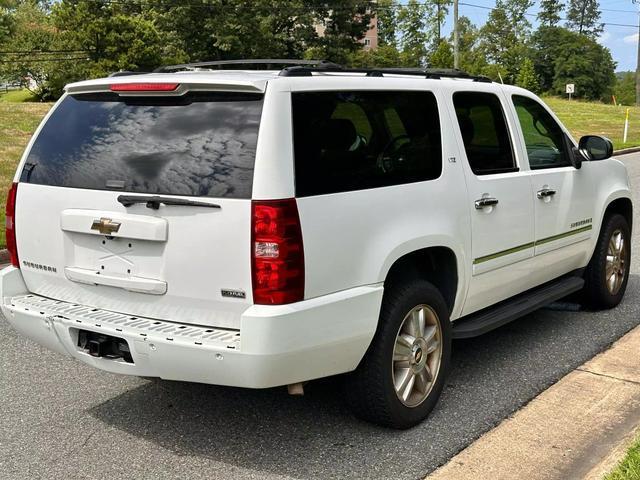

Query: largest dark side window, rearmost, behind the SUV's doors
left=291, top=91, right=442, bottom=197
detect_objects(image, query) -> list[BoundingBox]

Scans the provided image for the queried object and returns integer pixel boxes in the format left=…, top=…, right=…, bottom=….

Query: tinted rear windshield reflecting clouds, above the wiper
left=21, top=92, right=263, bottom=198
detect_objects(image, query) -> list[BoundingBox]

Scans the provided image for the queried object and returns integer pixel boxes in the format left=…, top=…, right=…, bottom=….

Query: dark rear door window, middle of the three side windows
left=453, top=92, right=518, bottom=175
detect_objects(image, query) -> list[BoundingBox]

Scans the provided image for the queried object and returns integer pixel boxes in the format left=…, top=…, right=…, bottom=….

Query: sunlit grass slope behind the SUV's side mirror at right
left=544, top=97, right=640, bottom=150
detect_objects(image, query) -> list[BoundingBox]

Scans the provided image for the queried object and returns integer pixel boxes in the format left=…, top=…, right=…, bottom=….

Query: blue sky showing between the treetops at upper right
left=445, top=0, right=640, bottom=71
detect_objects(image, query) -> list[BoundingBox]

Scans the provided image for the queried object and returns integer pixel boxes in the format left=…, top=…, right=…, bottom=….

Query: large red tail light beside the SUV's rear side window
left=251, top=198, right=304, bottom=305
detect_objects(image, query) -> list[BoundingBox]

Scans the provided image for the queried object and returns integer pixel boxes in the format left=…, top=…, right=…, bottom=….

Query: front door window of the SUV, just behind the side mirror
left=512, top=95, right=570, bottom=170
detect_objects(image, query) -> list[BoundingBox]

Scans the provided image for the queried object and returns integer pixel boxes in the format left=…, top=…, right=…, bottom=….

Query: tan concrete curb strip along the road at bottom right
left=427, top=327, right=640, bottom=480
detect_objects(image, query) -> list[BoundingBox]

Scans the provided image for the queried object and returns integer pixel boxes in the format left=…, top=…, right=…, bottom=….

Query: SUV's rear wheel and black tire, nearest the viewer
left=345, top=280, right=451, bottom=429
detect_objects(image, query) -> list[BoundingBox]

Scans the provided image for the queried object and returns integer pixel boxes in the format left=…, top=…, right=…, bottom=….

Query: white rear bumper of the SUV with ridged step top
left=0, top=267, right=383, bottom=388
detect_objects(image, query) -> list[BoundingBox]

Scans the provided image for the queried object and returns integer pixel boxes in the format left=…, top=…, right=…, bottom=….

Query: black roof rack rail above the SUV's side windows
left=280, top=63, right=493, bottom=83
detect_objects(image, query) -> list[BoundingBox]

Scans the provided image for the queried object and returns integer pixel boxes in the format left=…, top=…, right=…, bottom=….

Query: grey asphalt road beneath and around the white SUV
left=0, top=154, right=640, bottom=479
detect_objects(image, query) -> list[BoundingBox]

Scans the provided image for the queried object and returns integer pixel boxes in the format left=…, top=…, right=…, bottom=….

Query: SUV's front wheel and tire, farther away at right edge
left=583, top=214, right=631, bottom=310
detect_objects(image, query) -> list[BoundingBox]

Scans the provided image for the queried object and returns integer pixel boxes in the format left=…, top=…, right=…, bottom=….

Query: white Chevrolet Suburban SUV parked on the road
left=0, top=61, right=632, bottom=428
